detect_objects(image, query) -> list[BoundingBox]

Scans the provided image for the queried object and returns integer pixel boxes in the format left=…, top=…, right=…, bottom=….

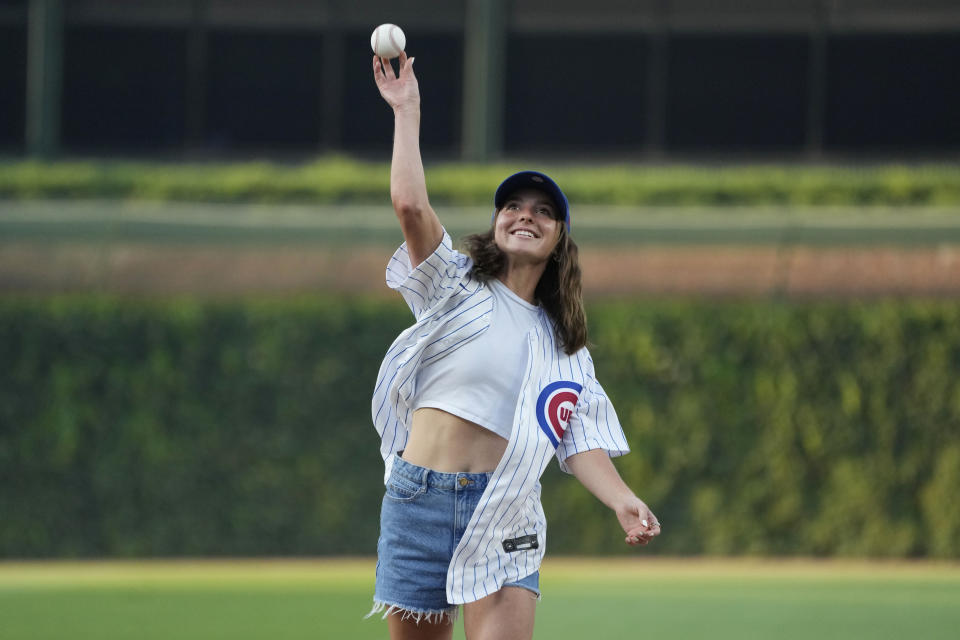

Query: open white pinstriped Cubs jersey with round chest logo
left=372, top=231, right=629, bottom=604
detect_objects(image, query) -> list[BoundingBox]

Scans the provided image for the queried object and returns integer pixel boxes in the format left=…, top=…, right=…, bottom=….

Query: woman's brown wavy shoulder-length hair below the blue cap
left=463, top=222, right=587, bottom=355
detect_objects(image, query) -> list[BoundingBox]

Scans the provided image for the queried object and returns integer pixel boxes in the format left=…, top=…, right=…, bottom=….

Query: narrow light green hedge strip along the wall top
left=0, top=157, right=960, bottom=206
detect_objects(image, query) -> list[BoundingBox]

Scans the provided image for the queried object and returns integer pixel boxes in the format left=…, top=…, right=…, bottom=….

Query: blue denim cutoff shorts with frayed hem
left=370, top=454, right=540, bottom=621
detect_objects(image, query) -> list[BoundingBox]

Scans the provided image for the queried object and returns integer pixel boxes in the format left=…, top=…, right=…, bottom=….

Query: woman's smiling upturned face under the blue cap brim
left=493, top=189, right=563, bottom=263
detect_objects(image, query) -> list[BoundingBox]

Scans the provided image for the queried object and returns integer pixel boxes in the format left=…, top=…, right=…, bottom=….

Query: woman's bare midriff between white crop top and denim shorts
left=401, top=408, right=507, bottom=473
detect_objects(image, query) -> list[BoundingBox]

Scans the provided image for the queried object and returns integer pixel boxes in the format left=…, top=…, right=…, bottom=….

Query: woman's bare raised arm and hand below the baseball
left=373, top=52, right=443, bottom=267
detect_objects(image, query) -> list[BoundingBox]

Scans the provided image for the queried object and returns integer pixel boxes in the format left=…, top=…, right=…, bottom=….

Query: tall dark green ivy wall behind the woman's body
left=0, top=297, right=960, bottom=558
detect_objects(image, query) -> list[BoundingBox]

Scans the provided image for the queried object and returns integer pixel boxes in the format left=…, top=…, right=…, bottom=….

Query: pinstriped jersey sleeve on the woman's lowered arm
left=557, top=356, right=630, bottom=473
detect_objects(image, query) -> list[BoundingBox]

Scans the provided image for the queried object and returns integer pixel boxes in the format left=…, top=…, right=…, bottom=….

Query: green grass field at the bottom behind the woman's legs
left=0, top=559, right=960, bottom=640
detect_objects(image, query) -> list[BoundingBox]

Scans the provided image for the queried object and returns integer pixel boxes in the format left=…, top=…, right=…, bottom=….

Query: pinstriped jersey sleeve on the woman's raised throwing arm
left=386, top=229, right=471, bottom=320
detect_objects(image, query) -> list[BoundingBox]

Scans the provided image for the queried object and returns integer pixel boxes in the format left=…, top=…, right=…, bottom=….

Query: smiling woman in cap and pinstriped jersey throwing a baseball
left=371, top=53, right=660, bottom=640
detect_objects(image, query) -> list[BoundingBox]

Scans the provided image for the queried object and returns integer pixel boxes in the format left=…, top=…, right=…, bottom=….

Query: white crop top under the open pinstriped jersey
left=413, top=278, right=540, bottom=440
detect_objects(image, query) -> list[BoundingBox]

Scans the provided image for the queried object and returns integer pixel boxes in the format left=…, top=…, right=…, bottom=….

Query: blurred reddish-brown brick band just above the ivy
left=0, top=241, right=960, bottom=298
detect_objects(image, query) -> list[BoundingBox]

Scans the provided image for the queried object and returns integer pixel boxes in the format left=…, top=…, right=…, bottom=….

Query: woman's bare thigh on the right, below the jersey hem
left=463, top=587, right=537, bottom=640
